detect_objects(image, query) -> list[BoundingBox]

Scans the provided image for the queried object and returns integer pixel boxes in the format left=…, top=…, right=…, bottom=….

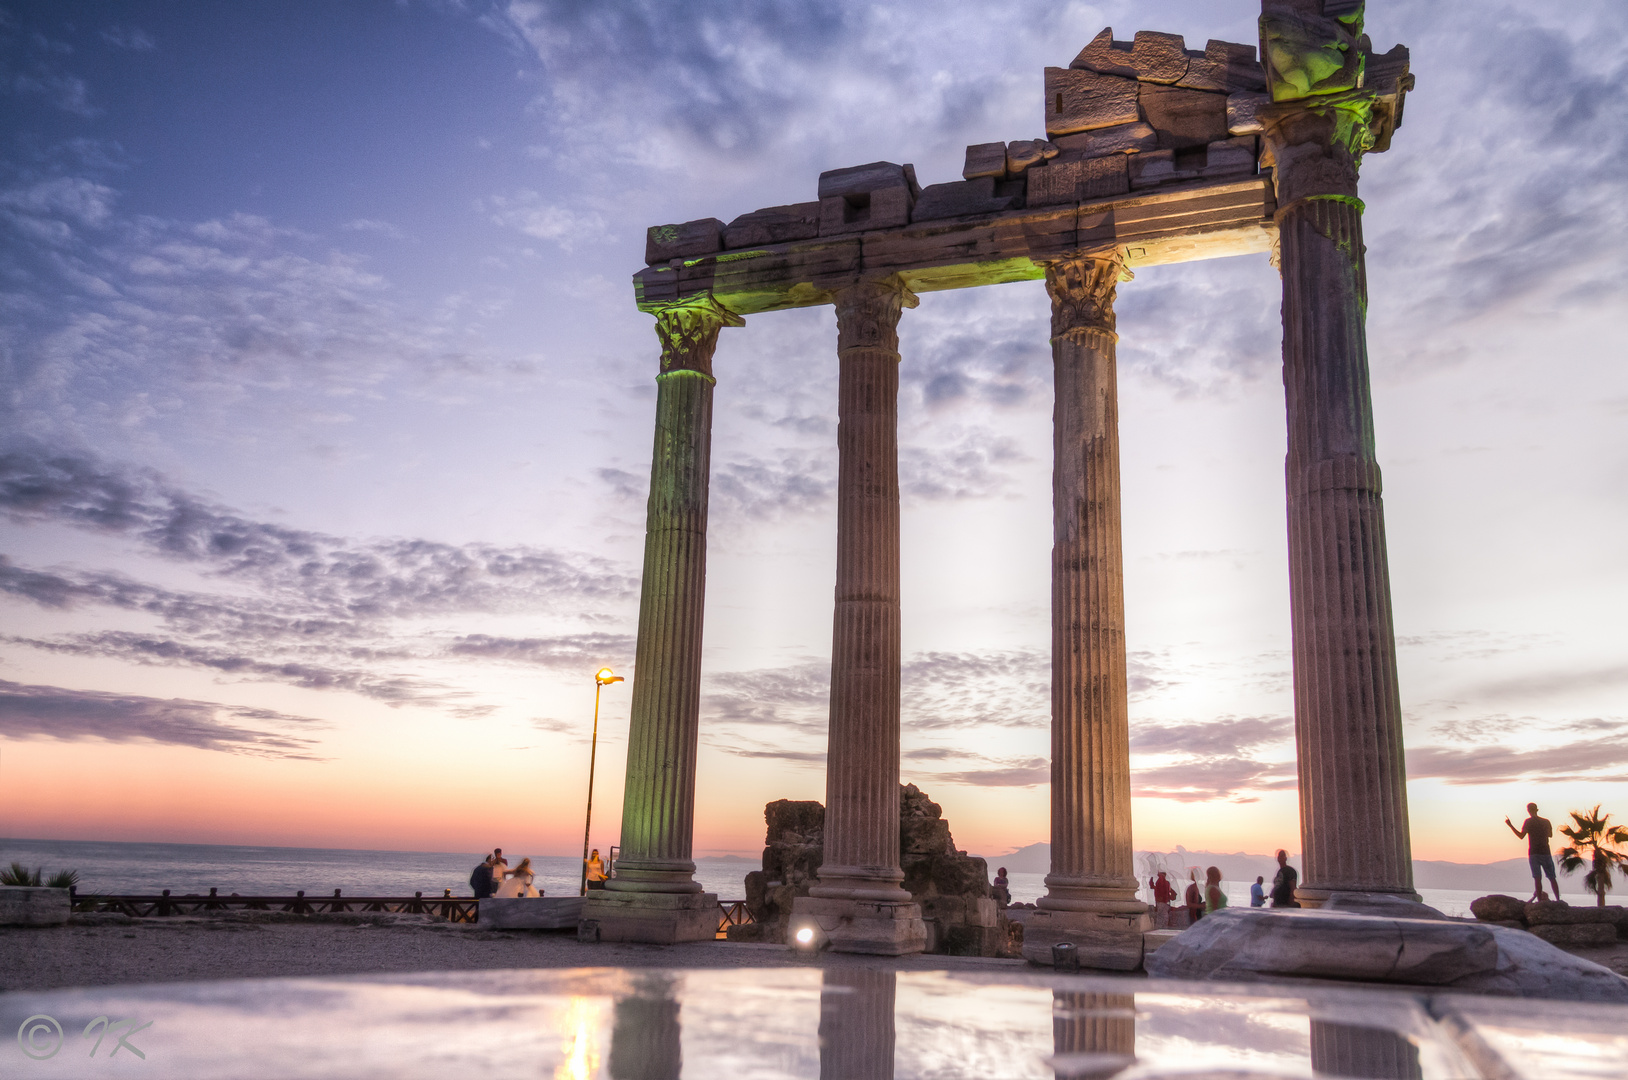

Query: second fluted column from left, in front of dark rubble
left=793, top=277, right=926, bottom=956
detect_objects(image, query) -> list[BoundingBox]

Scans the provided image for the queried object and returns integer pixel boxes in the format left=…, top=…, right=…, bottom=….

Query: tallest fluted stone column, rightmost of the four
left=1265, top=103, right=1416, bottom=906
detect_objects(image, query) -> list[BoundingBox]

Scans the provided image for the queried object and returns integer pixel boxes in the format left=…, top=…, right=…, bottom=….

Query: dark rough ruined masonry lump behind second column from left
left=729, top=784, right=1013, bottom=956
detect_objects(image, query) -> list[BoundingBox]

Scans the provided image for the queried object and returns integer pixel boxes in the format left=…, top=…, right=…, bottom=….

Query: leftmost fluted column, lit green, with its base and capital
left=583, top=295, right=744, bottom=942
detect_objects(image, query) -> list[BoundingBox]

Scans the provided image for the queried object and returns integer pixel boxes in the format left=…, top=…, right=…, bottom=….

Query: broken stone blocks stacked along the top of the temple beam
left=645, top=29, right=1289, bottom=266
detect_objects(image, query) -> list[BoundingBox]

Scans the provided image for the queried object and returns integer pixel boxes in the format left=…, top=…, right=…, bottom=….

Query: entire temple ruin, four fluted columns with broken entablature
left=584, top=0, right=1416, bottom=969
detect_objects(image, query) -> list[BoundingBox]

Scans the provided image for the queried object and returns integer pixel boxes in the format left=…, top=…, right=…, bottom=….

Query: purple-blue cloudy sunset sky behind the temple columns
left=0, top=0, right=1628, bottom=862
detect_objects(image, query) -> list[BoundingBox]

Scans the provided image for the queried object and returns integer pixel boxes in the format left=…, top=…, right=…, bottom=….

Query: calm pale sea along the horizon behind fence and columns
left=0, top=839, right=1481, bottom=915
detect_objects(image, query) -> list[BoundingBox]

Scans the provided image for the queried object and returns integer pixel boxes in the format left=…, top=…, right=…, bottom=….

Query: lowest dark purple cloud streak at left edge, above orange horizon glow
left=0, top=679, right=326, bottom=761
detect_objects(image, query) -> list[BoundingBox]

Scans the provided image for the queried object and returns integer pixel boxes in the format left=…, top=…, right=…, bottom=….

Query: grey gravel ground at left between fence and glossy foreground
left=0, top=912, right=1024, bottom=990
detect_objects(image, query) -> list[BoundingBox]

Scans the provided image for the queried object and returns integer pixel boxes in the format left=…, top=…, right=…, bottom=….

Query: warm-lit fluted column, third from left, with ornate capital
left=1024, top=251, right=1148, bottom=971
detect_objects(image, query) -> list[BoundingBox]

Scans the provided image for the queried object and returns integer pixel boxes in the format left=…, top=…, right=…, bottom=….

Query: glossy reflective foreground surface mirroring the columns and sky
left=0, top=959, right=1628, bottom=1080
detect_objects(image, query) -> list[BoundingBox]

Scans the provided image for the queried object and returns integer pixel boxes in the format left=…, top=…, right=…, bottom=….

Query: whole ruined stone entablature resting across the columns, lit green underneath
left=633, top=20, right=1411, bottom=314
